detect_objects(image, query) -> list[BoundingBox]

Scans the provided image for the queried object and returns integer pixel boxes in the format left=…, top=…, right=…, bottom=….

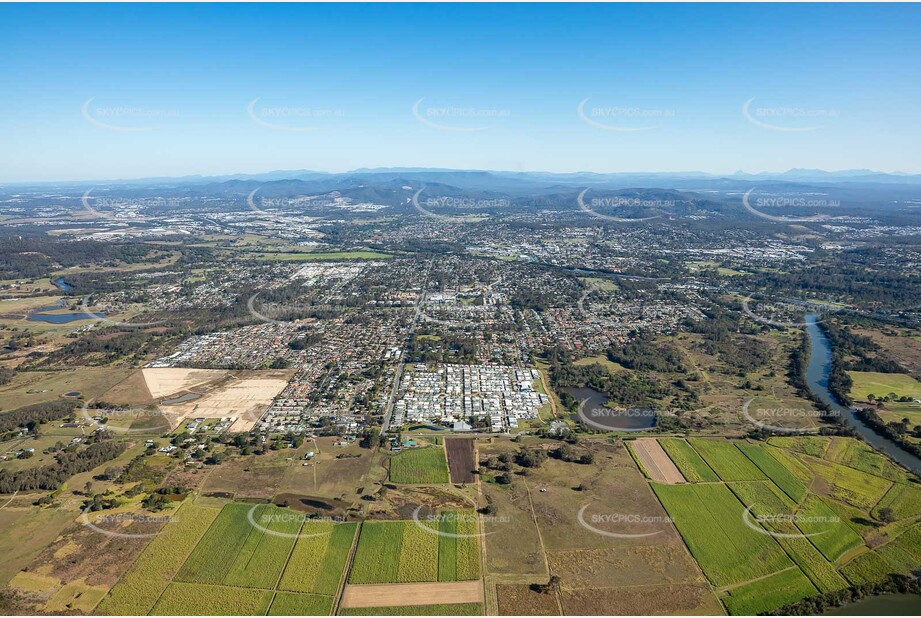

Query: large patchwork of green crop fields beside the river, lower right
left=647, top=436, right=921, bottom=614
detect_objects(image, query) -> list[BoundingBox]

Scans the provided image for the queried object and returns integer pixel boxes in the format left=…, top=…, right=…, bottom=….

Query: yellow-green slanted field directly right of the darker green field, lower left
left=278, top=521, right=358, bottom=596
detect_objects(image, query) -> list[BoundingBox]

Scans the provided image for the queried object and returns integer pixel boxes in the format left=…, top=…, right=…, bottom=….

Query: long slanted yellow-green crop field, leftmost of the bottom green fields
left=96, top=504, right=220, bottom=616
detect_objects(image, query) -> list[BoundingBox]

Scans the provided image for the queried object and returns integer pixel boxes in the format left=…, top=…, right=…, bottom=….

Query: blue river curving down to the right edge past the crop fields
left=806, top=313, right=921, bottom=475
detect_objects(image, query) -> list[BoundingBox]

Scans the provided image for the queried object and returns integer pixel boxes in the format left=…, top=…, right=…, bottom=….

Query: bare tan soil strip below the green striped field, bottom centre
left=340, top=579, right=483, bottom=608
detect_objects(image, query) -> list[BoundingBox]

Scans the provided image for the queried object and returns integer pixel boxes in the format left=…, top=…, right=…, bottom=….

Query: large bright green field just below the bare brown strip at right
left=653, top=482, right=793, bottom=587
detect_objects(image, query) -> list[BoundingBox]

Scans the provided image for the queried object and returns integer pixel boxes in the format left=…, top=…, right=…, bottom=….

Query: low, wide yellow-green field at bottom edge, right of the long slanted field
left=151, top=583, right=272, bottom=616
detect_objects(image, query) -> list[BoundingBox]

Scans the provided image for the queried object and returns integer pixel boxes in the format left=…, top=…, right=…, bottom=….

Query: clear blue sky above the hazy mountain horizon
left=0, top=4, right=921, bottom=182
